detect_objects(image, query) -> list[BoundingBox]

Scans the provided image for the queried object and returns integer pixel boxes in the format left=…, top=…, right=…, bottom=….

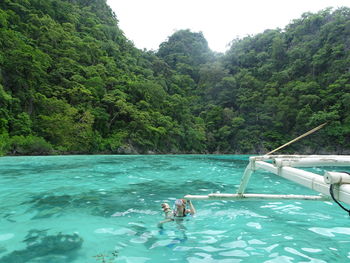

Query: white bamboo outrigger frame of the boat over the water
left=184, top=155, right=350, bottom=204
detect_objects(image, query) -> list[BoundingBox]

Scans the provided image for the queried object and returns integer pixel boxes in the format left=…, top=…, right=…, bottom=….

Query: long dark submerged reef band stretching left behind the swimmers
left=22, top=179, right=220, bottom=220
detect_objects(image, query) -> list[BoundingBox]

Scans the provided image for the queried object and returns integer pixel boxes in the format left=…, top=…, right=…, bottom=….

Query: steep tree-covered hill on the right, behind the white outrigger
left=199, top=8, right=350, bottom=153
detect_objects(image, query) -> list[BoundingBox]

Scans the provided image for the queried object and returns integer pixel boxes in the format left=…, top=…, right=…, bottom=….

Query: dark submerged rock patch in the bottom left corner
left=0, top=230, right=83, bottom=263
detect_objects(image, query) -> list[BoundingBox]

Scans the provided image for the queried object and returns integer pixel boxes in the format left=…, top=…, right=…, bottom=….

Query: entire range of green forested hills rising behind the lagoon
left=0, top=0, right=350, bottom=154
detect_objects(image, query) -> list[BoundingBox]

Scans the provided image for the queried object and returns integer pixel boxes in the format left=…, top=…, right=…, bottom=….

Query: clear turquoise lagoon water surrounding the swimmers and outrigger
left=0, top=155, right=350, bottom=263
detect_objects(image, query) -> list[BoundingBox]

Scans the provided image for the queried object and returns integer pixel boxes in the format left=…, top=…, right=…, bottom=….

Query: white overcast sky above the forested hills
left=107, top=0, right=350, bottom=52
